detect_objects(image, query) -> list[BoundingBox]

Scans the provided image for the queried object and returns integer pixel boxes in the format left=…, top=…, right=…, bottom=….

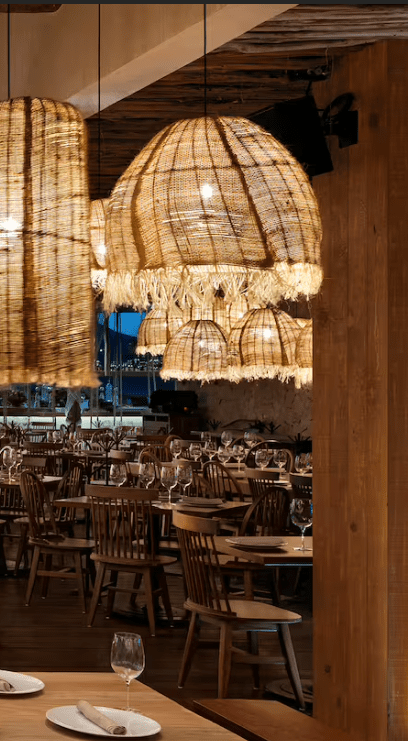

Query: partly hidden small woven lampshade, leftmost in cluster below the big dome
left=136, top=307, right=185, bottom=355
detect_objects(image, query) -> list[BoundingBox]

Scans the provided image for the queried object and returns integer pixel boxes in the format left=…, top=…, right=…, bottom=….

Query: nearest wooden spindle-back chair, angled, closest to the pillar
left=173, top=512, right=305, bottom=709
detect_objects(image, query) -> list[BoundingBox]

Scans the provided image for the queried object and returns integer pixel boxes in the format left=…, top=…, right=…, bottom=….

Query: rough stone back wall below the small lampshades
left=182, top=379, right=312, bottom=437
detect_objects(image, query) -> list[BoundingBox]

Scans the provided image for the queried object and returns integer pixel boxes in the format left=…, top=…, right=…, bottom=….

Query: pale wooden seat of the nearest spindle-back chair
left=184, top=600, right=302, bottom=630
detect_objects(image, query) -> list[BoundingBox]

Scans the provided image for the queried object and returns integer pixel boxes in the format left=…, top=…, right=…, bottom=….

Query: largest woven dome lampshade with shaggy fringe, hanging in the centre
left=104, top=116, right=322, bottom=312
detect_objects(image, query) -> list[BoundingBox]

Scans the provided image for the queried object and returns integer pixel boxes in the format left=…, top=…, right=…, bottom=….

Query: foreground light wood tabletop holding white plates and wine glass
left=0, top=670, right=247, bottom=741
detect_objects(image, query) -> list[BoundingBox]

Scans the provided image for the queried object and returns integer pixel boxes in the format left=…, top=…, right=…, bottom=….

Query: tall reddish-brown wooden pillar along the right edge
left=313, top=41, right=408, bottom=741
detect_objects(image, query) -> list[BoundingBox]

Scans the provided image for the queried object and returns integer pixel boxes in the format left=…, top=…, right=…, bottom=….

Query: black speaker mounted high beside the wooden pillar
left=248, top=95, right=333, bottom=177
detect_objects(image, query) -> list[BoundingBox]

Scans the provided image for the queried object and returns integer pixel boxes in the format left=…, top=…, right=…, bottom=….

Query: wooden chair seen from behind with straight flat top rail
left=85, top=485, right=177, bottom=636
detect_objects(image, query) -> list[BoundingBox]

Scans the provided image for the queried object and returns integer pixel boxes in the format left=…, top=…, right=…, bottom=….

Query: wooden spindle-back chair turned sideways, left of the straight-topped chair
left=20, top=471, right=95, bottom=612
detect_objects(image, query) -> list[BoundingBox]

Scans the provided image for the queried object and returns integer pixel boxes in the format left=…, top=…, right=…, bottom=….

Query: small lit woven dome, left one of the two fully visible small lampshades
left=160, top=319, right=228, bottom=383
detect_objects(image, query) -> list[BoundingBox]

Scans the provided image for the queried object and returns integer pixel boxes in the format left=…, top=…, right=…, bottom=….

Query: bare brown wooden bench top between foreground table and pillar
left=194, top=699, right=357, bottom=741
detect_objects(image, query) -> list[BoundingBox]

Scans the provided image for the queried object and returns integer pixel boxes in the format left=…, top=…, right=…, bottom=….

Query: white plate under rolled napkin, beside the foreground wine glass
left=46, top=705, right=161, bottom=738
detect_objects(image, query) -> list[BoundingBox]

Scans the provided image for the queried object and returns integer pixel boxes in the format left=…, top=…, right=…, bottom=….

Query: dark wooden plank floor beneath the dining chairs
left=0, top=524, right=312, bottom=712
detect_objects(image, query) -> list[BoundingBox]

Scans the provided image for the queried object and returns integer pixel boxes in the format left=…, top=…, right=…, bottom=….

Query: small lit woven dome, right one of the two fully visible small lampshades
left=228, top=308, right=301, bottom=382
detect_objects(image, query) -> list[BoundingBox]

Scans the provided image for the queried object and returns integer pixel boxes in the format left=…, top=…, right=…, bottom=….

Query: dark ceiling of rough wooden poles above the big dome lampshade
left=87, top=4, right=408, bottom=199
